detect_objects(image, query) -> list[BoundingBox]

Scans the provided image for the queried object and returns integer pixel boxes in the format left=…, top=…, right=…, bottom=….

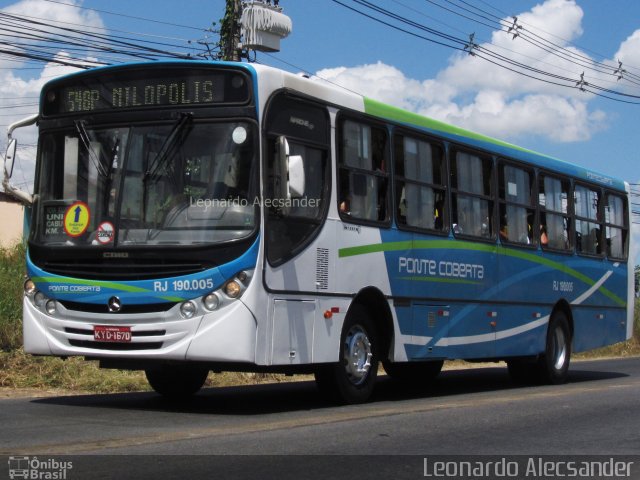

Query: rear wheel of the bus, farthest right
left=538, top=310, right=571, bottom=385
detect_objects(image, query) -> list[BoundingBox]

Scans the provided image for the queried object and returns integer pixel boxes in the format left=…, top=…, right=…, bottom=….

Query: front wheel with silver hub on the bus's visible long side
left=315, top=304, right=379, bottom=404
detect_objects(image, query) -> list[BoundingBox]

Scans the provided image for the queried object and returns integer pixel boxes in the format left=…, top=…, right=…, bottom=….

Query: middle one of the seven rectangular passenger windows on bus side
left=498, top=164, right=536, bottom=245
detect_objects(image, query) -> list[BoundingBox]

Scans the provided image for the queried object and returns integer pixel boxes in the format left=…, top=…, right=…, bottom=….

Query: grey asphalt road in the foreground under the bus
left=0, top=358, right=640, bottom=480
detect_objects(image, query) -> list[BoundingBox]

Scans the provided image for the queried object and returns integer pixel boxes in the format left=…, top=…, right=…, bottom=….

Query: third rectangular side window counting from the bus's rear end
left=538, top=175, right=573, bottom=251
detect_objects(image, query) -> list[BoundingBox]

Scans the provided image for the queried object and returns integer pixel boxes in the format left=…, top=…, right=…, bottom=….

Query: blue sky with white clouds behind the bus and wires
left=0, top=0, right=640, bottom=263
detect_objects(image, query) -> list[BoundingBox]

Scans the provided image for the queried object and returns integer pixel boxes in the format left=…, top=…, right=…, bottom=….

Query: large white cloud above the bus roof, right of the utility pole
left=318, top=0, right=620, bottom=142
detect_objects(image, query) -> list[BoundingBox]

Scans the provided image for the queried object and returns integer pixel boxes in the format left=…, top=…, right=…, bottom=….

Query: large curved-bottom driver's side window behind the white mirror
left=264, top=94, right=331, bottom=266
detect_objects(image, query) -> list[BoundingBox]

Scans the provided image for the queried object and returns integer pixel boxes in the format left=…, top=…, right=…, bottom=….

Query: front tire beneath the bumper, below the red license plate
left=145, top=365, right=209, bottom=400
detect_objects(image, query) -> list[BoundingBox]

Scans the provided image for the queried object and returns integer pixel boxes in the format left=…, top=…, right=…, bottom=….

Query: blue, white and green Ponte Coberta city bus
left=5, top=61, right=633, bottom=403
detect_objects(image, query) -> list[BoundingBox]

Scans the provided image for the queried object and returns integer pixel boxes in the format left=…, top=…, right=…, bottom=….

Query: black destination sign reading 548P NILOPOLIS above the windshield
left=43, top=68, right=250, bottom=115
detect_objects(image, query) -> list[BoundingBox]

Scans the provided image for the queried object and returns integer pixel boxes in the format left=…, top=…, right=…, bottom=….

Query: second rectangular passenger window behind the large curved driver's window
left=394, top=135, right=446, bottom=231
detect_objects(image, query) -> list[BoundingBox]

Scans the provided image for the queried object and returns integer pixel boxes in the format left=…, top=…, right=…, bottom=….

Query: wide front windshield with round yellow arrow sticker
left=32, top=119, right=257, bottom=248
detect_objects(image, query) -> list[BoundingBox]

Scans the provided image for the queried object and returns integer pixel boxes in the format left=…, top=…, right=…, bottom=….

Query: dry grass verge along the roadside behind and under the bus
left=0, top=245, right=640, bottom=393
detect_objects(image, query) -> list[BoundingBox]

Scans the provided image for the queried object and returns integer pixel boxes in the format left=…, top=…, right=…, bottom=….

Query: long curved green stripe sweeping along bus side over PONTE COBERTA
left=338, top=240, right=627, bottom=307
